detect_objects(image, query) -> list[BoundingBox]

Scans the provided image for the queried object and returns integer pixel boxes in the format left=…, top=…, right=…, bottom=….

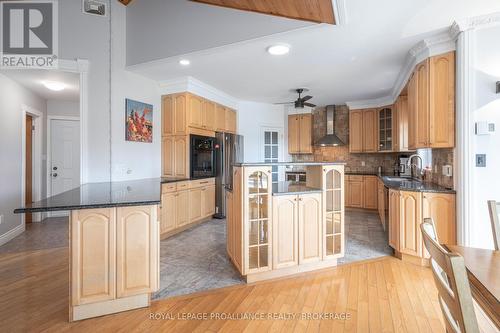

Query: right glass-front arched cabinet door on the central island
left=323, top=165, right=345, bottom=259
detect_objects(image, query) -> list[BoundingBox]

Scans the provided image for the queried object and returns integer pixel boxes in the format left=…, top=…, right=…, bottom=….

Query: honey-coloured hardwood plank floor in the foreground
left=0, top=247, right=444, bottom=333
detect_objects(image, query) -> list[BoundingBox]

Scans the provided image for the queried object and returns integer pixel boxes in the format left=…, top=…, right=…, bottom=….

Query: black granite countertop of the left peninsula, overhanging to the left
left=14, top=178, right=161, bottom=214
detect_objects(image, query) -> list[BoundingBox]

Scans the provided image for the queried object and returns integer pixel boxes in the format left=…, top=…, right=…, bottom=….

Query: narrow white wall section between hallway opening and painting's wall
left=59, top=0, right=111, bottom=182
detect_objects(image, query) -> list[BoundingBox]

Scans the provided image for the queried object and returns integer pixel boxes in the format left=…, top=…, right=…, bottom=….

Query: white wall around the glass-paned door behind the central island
left=238, top=101, right=288, bottom=162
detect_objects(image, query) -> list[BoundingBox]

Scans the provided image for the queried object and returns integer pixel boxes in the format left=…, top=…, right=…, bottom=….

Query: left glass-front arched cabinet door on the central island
left=243, top=167, right=272, bottom=275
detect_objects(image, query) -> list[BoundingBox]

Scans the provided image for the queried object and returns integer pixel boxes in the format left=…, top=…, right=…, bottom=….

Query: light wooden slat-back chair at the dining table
left=420, top=219, right=479, bottom=333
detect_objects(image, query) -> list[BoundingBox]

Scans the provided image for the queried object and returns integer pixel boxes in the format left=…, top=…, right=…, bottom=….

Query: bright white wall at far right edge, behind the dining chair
left=471, top=26, right=500, bottom=248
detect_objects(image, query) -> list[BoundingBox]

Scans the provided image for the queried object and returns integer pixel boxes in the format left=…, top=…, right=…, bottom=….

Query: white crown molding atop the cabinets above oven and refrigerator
left=158, top=76, right=241, bottom=109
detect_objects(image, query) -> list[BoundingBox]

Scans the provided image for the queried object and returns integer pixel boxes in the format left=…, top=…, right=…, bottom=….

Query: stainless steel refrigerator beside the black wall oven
left=214, top=132, right=243, bottom=219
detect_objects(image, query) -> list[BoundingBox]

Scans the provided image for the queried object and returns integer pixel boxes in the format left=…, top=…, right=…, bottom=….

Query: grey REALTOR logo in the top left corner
left=0, top=0, right=58, bottom=68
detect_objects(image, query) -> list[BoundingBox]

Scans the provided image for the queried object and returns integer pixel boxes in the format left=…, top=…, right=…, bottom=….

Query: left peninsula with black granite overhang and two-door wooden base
left=15, top=179, right=161, bottom=321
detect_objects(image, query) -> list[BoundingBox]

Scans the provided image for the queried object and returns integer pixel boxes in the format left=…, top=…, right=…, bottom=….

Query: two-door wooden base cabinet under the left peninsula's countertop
left=70, top=205, right=160, bottom=321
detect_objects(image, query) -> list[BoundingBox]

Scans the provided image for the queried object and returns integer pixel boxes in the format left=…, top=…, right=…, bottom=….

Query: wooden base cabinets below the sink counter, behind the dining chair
left=389, top=189, right=456, bottom=265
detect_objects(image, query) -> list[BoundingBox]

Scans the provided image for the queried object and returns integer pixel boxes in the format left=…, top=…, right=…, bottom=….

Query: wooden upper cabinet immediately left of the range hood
left=288, top=114, right=313, bottom=154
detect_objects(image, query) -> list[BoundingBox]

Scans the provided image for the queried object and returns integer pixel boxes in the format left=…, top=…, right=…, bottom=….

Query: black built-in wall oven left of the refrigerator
left=190, top=135, right=215, bottom=178
